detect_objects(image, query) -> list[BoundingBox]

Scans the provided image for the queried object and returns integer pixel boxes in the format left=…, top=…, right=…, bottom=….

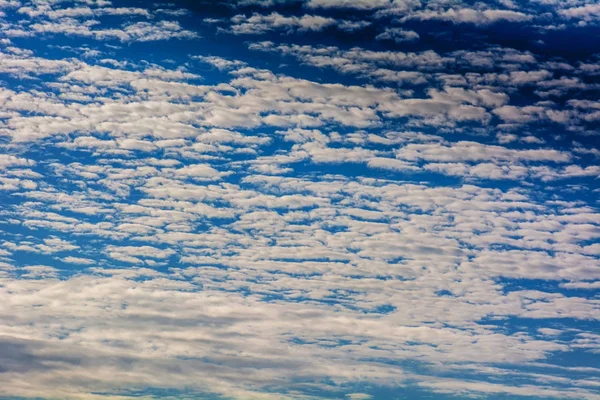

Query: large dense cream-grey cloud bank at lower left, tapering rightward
left=3, top=269, right=586, bottom=398
